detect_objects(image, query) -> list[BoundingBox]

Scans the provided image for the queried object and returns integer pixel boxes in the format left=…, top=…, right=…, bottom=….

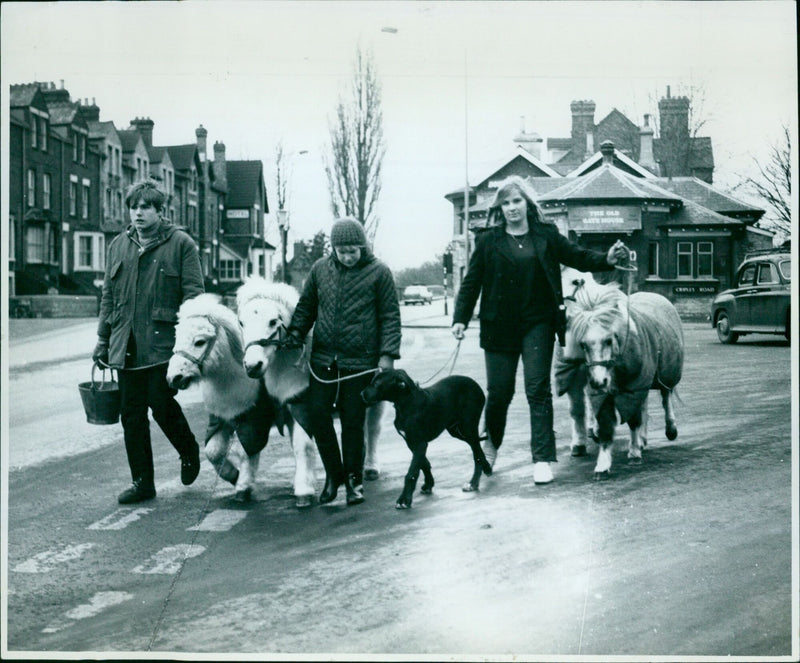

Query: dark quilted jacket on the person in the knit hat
left=289, top=248, right=401, bottom=371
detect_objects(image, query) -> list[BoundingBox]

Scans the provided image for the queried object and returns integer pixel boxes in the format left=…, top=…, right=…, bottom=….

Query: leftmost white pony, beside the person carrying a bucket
left=167, top=294, right=314, bottom=506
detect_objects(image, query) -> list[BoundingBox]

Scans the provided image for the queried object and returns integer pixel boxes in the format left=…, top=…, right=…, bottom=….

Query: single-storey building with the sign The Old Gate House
left=445, top=99, right=773, bottom=321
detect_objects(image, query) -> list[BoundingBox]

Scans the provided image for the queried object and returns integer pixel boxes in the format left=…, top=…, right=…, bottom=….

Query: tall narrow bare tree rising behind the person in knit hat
left=325, top=45, right=386, bottom=240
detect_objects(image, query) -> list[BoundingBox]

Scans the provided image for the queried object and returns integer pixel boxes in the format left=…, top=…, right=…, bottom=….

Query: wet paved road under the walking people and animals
left=4, top=318, right=798, bottom=659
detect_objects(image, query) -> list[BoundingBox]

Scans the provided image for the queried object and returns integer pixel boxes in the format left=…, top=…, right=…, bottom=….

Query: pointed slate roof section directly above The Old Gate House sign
left=539, top=164, right=680, bottom=204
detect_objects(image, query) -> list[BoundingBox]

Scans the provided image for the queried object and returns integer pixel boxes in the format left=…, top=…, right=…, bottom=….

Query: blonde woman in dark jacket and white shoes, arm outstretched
left=452, top=176, right=627, bottom=484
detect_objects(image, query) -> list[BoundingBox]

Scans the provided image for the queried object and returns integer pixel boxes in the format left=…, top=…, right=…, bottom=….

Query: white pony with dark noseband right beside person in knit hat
left=236, top=277, right=385, bottom=480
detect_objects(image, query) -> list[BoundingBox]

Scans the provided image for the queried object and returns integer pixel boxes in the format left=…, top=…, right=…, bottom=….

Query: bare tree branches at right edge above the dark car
left=744, top=125, right=792, bottom=235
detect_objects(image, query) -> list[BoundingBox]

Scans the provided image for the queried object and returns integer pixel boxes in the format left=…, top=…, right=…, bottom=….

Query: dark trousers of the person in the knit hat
left=308, top=365, right=373, bottom=484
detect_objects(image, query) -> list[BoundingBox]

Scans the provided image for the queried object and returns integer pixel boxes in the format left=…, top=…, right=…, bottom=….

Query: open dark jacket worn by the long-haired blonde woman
left=453, top=223, right=614, bottom=351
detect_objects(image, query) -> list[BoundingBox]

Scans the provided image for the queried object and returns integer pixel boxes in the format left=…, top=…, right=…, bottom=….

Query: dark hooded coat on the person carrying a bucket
left=97, top=223, right=203, bottom=368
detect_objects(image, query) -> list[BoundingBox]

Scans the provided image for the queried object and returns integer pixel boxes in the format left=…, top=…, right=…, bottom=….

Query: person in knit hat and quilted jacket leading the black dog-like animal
left=289, top=217, right=401, bottom=505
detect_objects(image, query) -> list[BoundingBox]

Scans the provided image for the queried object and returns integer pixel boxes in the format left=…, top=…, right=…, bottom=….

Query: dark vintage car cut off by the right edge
left=711, top=250, right=792, bottom=343
